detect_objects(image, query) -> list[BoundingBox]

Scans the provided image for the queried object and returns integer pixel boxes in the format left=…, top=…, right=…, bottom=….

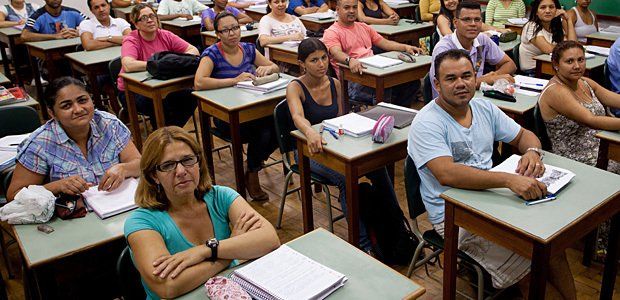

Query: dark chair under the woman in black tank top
left=273, top=100, right=344, bottom=232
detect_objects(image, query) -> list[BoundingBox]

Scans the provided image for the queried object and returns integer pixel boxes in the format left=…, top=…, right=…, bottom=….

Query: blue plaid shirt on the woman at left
left=16, top=110, right=131, bottom=184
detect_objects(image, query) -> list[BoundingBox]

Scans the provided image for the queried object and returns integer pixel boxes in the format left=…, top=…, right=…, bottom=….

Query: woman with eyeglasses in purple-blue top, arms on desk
left=194, top=11, right=280, bottom=201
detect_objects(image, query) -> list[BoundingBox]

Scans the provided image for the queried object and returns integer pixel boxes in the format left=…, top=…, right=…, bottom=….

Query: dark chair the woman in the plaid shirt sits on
left=0, top=106, right=41, bottom=281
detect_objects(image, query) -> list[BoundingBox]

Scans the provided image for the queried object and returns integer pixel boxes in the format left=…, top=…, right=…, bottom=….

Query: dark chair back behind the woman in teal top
left=116, top=246, right=146, bottom=300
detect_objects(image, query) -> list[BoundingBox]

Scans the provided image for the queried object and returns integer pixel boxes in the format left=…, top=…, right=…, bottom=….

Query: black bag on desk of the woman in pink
left=146, top=51, right=200, bottom=80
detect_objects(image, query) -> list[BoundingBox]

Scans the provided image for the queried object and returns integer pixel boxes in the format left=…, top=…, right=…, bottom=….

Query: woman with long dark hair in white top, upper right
left=519, top=0, right=577, bottom=76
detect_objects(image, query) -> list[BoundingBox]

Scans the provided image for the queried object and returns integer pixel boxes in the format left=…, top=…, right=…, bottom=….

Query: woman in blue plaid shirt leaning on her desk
left=7, top=77, right=140, bottom=200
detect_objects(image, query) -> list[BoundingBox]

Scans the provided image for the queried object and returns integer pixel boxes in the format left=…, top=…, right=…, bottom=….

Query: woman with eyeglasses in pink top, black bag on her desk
left=117, top=3, right=199, bottom=127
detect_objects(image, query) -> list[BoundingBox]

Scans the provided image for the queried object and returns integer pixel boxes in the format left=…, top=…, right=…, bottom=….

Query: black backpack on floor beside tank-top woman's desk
left=359, top=182, right=418, bottom=265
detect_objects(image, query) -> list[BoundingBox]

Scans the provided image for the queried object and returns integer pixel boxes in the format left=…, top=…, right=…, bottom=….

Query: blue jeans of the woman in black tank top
left=295, top=151, right=398, bottom=251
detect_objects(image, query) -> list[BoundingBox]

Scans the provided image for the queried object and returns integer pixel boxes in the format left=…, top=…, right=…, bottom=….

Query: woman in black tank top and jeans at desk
left=286, top=38, right=397, bottom=252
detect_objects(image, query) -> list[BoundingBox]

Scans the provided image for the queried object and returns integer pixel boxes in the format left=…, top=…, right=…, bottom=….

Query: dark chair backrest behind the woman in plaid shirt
left=0, top=106, right=40, bottom=137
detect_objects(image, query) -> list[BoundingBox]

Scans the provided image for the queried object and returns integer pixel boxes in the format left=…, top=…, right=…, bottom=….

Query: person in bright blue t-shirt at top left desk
left=21, top=0, right=88, bottom=42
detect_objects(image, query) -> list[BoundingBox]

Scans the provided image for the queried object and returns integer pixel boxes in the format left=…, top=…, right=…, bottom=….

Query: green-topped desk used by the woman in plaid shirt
left=11, top=212, right=129, bottom=298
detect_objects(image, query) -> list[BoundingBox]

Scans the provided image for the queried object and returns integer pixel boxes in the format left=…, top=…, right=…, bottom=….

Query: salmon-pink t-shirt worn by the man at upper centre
left=323, top=22, right=383, bottom=74
